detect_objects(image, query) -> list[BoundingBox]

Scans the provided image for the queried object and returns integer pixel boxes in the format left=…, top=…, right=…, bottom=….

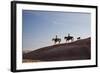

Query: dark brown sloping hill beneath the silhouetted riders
left=23, top=38, right=91, bottom=62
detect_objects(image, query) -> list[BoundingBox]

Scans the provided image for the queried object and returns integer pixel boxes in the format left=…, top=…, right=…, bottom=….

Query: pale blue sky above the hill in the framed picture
left=22, top=10, right=91, bottom=50
